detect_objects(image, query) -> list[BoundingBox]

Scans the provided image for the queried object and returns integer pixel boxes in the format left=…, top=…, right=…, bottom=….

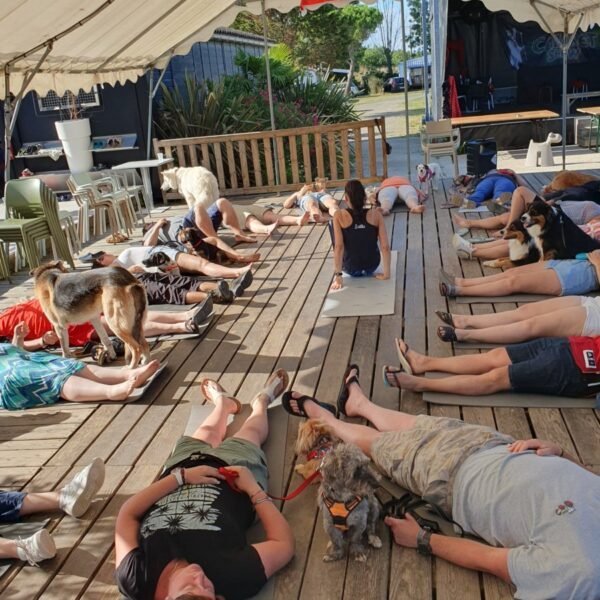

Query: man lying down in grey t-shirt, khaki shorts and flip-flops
left=283, top=366, right=600, bottom=599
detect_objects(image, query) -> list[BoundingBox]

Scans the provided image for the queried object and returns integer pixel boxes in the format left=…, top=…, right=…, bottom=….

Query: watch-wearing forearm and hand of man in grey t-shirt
left=385, top=514, right=511, bottom=583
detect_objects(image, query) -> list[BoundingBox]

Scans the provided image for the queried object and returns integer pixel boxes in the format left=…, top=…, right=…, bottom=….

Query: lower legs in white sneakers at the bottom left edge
left=0, top=458, right=104, bottom=565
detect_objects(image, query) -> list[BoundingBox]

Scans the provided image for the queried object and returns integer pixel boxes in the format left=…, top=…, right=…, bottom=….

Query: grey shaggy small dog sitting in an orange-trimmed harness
left=319, top=443, right=381, bottom=562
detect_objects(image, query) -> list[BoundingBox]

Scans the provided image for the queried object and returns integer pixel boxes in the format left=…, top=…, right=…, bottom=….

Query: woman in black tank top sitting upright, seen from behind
left=331, top=179, right=390, bottom=290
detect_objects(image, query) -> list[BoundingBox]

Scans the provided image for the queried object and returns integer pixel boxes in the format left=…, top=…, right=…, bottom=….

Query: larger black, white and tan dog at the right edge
left=521, top=197, right=600, bottom=260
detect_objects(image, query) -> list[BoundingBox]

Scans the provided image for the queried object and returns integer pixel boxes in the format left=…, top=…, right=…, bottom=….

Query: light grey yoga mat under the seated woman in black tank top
left=321, top=251, right=398, bottom=317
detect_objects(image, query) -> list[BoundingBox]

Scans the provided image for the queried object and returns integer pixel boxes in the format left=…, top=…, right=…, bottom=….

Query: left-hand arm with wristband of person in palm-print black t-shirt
left=115, top=465, right=224, bottom=567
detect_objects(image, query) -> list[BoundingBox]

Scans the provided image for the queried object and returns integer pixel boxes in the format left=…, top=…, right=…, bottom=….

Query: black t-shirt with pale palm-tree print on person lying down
left=116, top=466, right=267, bottom=600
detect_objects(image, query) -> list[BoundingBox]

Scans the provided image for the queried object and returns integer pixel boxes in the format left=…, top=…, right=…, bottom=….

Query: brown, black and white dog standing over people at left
left=32, top=261, right=150, bottom=368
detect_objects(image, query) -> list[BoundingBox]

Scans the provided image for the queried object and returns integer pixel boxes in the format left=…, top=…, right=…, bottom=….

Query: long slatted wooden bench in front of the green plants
left=153, top=117, right=387, bottom=201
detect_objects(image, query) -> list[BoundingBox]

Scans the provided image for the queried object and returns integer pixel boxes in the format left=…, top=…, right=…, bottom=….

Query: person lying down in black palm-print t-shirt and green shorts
left=115, top=369, right=294, bottom=600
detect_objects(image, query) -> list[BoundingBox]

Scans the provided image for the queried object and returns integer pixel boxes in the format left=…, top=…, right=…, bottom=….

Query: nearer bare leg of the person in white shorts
left=455, top=298, right=587, bottom=344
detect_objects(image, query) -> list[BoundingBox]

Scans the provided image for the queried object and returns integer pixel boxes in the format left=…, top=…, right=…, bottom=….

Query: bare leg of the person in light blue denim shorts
left=456, top=269, right=562, bottom=296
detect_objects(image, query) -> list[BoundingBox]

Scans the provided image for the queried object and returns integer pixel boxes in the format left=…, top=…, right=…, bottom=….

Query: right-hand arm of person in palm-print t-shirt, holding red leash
left=229, top=466, right=295, bottom=578
